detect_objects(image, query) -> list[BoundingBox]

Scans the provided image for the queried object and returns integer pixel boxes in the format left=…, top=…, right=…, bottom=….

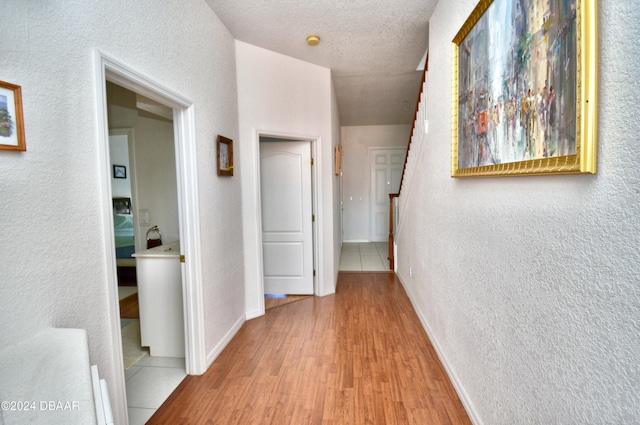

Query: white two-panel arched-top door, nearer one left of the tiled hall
left=260, top=141, right=313, bottom=294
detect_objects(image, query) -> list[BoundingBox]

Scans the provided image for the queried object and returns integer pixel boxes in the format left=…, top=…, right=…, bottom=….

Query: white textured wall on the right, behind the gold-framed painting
left=398, top=0, right=640, bottom=425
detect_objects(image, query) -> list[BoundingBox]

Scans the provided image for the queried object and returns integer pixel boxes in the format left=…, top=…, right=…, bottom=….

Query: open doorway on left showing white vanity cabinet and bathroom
left=106, top=81, right=186, bottom=423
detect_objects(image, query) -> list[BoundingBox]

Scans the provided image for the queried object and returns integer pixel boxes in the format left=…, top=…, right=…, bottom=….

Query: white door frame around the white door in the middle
left=254, top=130, right=322, bottom=315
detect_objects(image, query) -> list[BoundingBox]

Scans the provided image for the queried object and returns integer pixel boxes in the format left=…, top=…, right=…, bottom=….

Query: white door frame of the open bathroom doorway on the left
left=95, top=50, right=207, bottom=424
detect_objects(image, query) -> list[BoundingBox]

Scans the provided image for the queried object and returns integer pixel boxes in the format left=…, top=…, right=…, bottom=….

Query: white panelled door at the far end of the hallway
left=369, top=149, right=406, bottom=242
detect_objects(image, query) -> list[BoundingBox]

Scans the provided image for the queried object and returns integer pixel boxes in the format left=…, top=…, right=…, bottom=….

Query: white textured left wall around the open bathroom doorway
left=0, top=0, right=244, bottom=423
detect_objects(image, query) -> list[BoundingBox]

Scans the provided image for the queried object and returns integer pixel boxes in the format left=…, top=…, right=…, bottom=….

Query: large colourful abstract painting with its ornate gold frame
left=451, top=0, right=598, bottom=177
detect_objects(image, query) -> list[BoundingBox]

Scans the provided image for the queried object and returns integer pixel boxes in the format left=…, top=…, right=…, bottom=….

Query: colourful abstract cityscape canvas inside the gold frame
left=457, top=0, right=577, bottom=169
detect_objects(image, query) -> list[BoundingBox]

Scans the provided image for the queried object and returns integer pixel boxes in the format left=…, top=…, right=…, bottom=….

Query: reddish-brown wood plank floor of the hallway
left=147, top=272, right=471, bottom=425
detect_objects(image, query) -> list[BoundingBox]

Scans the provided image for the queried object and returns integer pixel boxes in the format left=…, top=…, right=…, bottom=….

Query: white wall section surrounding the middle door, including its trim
left=236, top=41, right=337, bottom=318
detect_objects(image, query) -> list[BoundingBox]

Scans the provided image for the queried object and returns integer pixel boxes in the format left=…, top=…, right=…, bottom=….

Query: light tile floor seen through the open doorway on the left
left=118, top=286, right=187, bottom=425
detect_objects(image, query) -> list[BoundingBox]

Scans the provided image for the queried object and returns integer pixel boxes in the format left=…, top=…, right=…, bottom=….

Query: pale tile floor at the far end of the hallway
left=340, top=242, right=390, bottom=272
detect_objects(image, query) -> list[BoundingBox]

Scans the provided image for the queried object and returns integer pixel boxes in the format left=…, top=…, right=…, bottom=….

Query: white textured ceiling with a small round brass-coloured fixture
left=206, top=0, right=438, bottom=126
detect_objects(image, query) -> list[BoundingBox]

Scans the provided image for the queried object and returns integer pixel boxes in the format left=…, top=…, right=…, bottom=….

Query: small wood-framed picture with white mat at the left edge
left=0, top=81, right=27, bottom=151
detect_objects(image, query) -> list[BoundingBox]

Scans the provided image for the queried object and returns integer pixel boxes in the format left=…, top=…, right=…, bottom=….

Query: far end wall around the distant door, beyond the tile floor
left=341, top=125, right=411, bottom=242
